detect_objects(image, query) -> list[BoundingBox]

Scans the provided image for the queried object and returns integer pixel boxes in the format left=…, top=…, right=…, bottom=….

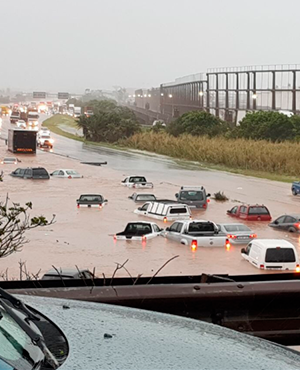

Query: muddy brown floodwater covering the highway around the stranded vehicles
left=0, top=119, right=300, bottom=278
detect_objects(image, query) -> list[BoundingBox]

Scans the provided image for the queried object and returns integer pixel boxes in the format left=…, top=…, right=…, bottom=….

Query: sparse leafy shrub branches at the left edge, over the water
left=0, top=196, right=55, bottom=258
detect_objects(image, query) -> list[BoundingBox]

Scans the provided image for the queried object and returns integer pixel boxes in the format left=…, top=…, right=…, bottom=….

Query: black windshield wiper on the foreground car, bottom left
left=0, top=288, right=59, bottom=369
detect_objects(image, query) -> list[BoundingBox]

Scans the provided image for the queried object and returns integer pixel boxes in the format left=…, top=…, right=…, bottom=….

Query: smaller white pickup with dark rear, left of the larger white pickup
left=114, top=221, right=163, bottom=241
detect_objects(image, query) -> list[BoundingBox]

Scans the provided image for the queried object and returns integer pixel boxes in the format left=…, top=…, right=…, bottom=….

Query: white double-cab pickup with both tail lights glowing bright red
left=161, top=220, right=230, bottom=249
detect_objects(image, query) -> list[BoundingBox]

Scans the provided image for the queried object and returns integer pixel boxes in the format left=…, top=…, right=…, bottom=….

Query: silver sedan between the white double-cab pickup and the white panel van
left=217, top=224, right=257, bottom=244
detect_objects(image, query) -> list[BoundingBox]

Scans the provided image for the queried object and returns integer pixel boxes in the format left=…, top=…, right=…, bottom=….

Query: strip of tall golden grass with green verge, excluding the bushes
left=43, top=115, right=300, bottom=182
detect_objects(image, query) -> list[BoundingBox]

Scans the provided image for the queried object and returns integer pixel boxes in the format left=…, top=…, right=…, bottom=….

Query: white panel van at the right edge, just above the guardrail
left=241, top=239, right=300, bottom=272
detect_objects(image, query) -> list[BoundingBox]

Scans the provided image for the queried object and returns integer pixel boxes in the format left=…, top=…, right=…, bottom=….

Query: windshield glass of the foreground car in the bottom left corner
left=0, top=302, right=42, bottom=370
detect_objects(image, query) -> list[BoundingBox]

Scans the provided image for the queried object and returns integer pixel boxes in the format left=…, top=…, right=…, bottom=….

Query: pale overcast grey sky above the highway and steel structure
left=0, top=0, right=300, bottom=92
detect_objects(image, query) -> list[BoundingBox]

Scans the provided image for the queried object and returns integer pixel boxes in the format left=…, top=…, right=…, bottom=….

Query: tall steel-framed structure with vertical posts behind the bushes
left=132, top=64, right=300, bottom=124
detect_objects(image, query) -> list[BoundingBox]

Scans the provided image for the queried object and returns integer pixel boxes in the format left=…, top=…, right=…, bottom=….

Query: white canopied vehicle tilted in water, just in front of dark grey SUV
left=134, top=200, right=191, bottom=222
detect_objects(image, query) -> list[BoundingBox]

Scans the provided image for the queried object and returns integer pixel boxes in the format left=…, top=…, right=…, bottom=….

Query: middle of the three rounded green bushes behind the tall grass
left=167, top=111, right=229, bottom=137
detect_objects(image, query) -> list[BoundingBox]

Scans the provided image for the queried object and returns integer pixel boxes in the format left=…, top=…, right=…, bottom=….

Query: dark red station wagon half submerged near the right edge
left=227, top=204, right=272, bottom=221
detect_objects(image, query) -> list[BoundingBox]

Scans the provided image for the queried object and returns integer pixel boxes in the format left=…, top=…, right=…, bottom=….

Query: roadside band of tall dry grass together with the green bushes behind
left=44, top=100, right=300, bottom=181
